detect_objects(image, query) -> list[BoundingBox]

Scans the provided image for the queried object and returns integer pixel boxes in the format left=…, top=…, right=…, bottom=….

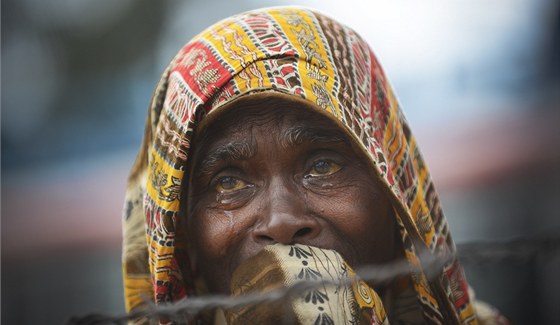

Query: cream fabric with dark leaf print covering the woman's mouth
left=225, top=244, right=389, bottom=324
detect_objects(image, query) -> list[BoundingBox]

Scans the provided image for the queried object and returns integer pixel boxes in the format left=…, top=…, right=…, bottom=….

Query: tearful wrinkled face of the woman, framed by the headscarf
left=187, top=99, right=395, bottom=294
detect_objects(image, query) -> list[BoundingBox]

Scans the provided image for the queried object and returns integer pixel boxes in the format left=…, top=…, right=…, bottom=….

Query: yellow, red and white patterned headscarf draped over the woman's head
left=123, top=8, right=476, bottom=324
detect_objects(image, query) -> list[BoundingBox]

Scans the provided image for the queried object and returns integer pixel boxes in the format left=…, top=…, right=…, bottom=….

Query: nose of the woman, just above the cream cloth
left=253, top=177, right=321, bottom=245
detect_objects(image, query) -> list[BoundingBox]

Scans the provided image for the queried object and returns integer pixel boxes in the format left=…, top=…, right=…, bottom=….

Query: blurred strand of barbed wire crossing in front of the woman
left=67, top=237, right=560, bottom=325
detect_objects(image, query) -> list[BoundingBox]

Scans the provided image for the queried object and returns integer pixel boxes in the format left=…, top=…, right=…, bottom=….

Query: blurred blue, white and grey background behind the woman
left=1, top=0, right=560, bottom=324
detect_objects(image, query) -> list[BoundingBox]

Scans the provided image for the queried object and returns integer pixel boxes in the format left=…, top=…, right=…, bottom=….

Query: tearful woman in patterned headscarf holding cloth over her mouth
left=123, top=8, right=505, bottom=324
